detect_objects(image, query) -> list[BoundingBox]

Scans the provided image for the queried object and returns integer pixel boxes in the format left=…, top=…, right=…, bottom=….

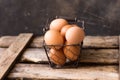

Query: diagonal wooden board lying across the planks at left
left=0, top=33, right=33, bottom=80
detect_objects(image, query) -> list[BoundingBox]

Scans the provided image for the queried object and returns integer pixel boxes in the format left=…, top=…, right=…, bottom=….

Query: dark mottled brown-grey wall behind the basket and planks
left=0, top=0, right=120, bottom=36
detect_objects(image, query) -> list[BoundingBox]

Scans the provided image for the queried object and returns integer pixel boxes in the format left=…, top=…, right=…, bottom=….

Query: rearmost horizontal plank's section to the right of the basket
left=83, top=36, right=118, bottom=48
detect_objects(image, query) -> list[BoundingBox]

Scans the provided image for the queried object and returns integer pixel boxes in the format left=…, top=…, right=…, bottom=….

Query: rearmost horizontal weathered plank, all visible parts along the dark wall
left=0, top=36, right=118, bottom=48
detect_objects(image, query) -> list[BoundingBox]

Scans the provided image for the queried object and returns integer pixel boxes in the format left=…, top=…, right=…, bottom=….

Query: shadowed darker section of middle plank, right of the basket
left=80, top=49, right=118, bottom=64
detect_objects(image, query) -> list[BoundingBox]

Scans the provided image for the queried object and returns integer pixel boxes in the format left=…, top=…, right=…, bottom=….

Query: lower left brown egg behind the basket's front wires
left=49, top=49, right=66, bottom=65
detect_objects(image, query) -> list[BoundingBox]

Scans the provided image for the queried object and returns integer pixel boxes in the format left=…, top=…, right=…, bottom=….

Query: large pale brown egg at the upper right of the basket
left=65, top=25, right=85, bottom=44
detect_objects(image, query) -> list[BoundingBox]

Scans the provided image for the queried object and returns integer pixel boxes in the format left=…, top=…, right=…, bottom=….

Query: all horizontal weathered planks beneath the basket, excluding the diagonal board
left=0, top=36, right=119, bottom=80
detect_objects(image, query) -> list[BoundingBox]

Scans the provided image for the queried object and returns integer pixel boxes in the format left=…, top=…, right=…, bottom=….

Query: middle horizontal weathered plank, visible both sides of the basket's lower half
left=0, top=48, right=119, bottom=64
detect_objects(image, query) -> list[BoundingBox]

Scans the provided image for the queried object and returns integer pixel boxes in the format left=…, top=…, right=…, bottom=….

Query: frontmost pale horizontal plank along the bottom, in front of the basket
left=8, top=64, right=118, bottom=80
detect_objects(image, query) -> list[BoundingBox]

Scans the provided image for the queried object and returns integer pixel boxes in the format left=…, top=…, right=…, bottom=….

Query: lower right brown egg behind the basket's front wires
left=63, top=42, right=80, bottom=61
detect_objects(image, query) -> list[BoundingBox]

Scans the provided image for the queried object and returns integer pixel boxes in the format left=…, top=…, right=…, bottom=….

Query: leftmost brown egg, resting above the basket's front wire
left=44, top=30, right=64, bottom=49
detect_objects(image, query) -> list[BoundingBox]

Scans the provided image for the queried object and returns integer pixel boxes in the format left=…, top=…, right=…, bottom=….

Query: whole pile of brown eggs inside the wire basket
left=44, top=18, right=85, bottom=65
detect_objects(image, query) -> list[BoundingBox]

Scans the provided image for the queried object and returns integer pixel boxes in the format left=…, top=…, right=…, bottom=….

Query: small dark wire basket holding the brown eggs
left=43, top=16, right=85, bottom=68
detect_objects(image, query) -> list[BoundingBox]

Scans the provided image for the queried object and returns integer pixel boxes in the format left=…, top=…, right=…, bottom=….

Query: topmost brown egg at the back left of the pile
left=50, top=18, right=68, bottom=31
